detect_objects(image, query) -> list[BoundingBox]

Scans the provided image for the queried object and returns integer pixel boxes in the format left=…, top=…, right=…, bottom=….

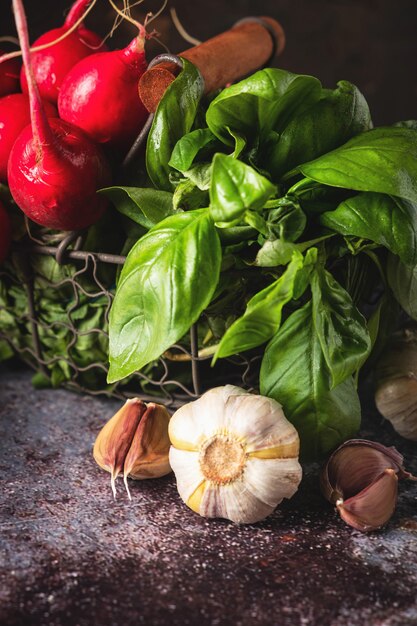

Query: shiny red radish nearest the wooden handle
left=58, top=22, right=148, bottom=151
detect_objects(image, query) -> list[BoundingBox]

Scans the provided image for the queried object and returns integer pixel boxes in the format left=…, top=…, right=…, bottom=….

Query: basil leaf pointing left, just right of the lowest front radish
left=99, top=187, right=175, bottom=230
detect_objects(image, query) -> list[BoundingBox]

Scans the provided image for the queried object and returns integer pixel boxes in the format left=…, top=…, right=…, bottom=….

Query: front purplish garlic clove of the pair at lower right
left=336, top=469, right=398, bottom=532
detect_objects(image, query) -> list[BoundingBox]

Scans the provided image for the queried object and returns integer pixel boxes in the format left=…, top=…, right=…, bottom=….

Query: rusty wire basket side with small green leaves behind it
left=0, top=223, right=261, bottom=408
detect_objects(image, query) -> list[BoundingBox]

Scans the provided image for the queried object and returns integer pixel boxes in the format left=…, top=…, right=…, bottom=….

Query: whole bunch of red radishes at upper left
left=0, top=0, right=147, bottom=261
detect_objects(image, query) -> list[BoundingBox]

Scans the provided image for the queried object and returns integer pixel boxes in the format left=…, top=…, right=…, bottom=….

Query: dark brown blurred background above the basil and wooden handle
left=0, top=0, right=417, bottom=125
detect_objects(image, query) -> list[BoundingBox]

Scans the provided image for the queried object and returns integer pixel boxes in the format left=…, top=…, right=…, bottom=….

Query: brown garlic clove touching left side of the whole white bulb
left=123, top=402, right=171, bottom=499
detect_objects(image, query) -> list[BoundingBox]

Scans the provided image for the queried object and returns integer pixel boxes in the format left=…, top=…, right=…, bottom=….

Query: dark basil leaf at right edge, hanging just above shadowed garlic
left=387, top=254, right=417, bottom=320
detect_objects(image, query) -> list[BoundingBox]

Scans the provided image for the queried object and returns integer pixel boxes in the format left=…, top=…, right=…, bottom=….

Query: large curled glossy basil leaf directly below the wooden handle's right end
left=206, top=68, right=321, bottom=145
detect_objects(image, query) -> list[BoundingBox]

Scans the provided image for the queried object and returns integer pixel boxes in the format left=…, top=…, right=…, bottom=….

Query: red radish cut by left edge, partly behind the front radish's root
left=0, top=93, right=58, bottom=183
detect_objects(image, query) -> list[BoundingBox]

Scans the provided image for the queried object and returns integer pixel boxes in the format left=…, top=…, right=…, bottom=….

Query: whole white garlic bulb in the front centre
left=169, top=385, right=302, bottom=524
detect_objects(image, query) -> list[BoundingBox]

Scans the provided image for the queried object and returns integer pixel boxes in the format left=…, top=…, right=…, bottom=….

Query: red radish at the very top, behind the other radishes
left=20, top=0, right=106, bottom=102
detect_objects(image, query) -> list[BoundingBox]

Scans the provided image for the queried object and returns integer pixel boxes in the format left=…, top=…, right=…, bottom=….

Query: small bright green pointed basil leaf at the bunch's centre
left=210, top=152, right=276, bottom=222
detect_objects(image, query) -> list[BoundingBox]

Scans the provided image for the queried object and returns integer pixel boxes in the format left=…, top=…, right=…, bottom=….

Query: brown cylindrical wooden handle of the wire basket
left=139, top=17, right=285, bottom=113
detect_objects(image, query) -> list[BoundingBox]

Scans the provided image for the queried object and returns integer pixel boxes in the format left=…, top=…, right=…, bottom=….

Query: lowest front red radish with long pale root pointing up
left=8, top=0, right=110, bottom=230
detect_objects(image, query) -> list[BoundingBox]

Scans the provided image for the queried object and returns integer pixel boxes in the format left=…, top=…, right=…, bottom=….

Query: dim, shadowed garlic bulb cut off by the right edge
left=375, top=322, right=417, bottom=441
